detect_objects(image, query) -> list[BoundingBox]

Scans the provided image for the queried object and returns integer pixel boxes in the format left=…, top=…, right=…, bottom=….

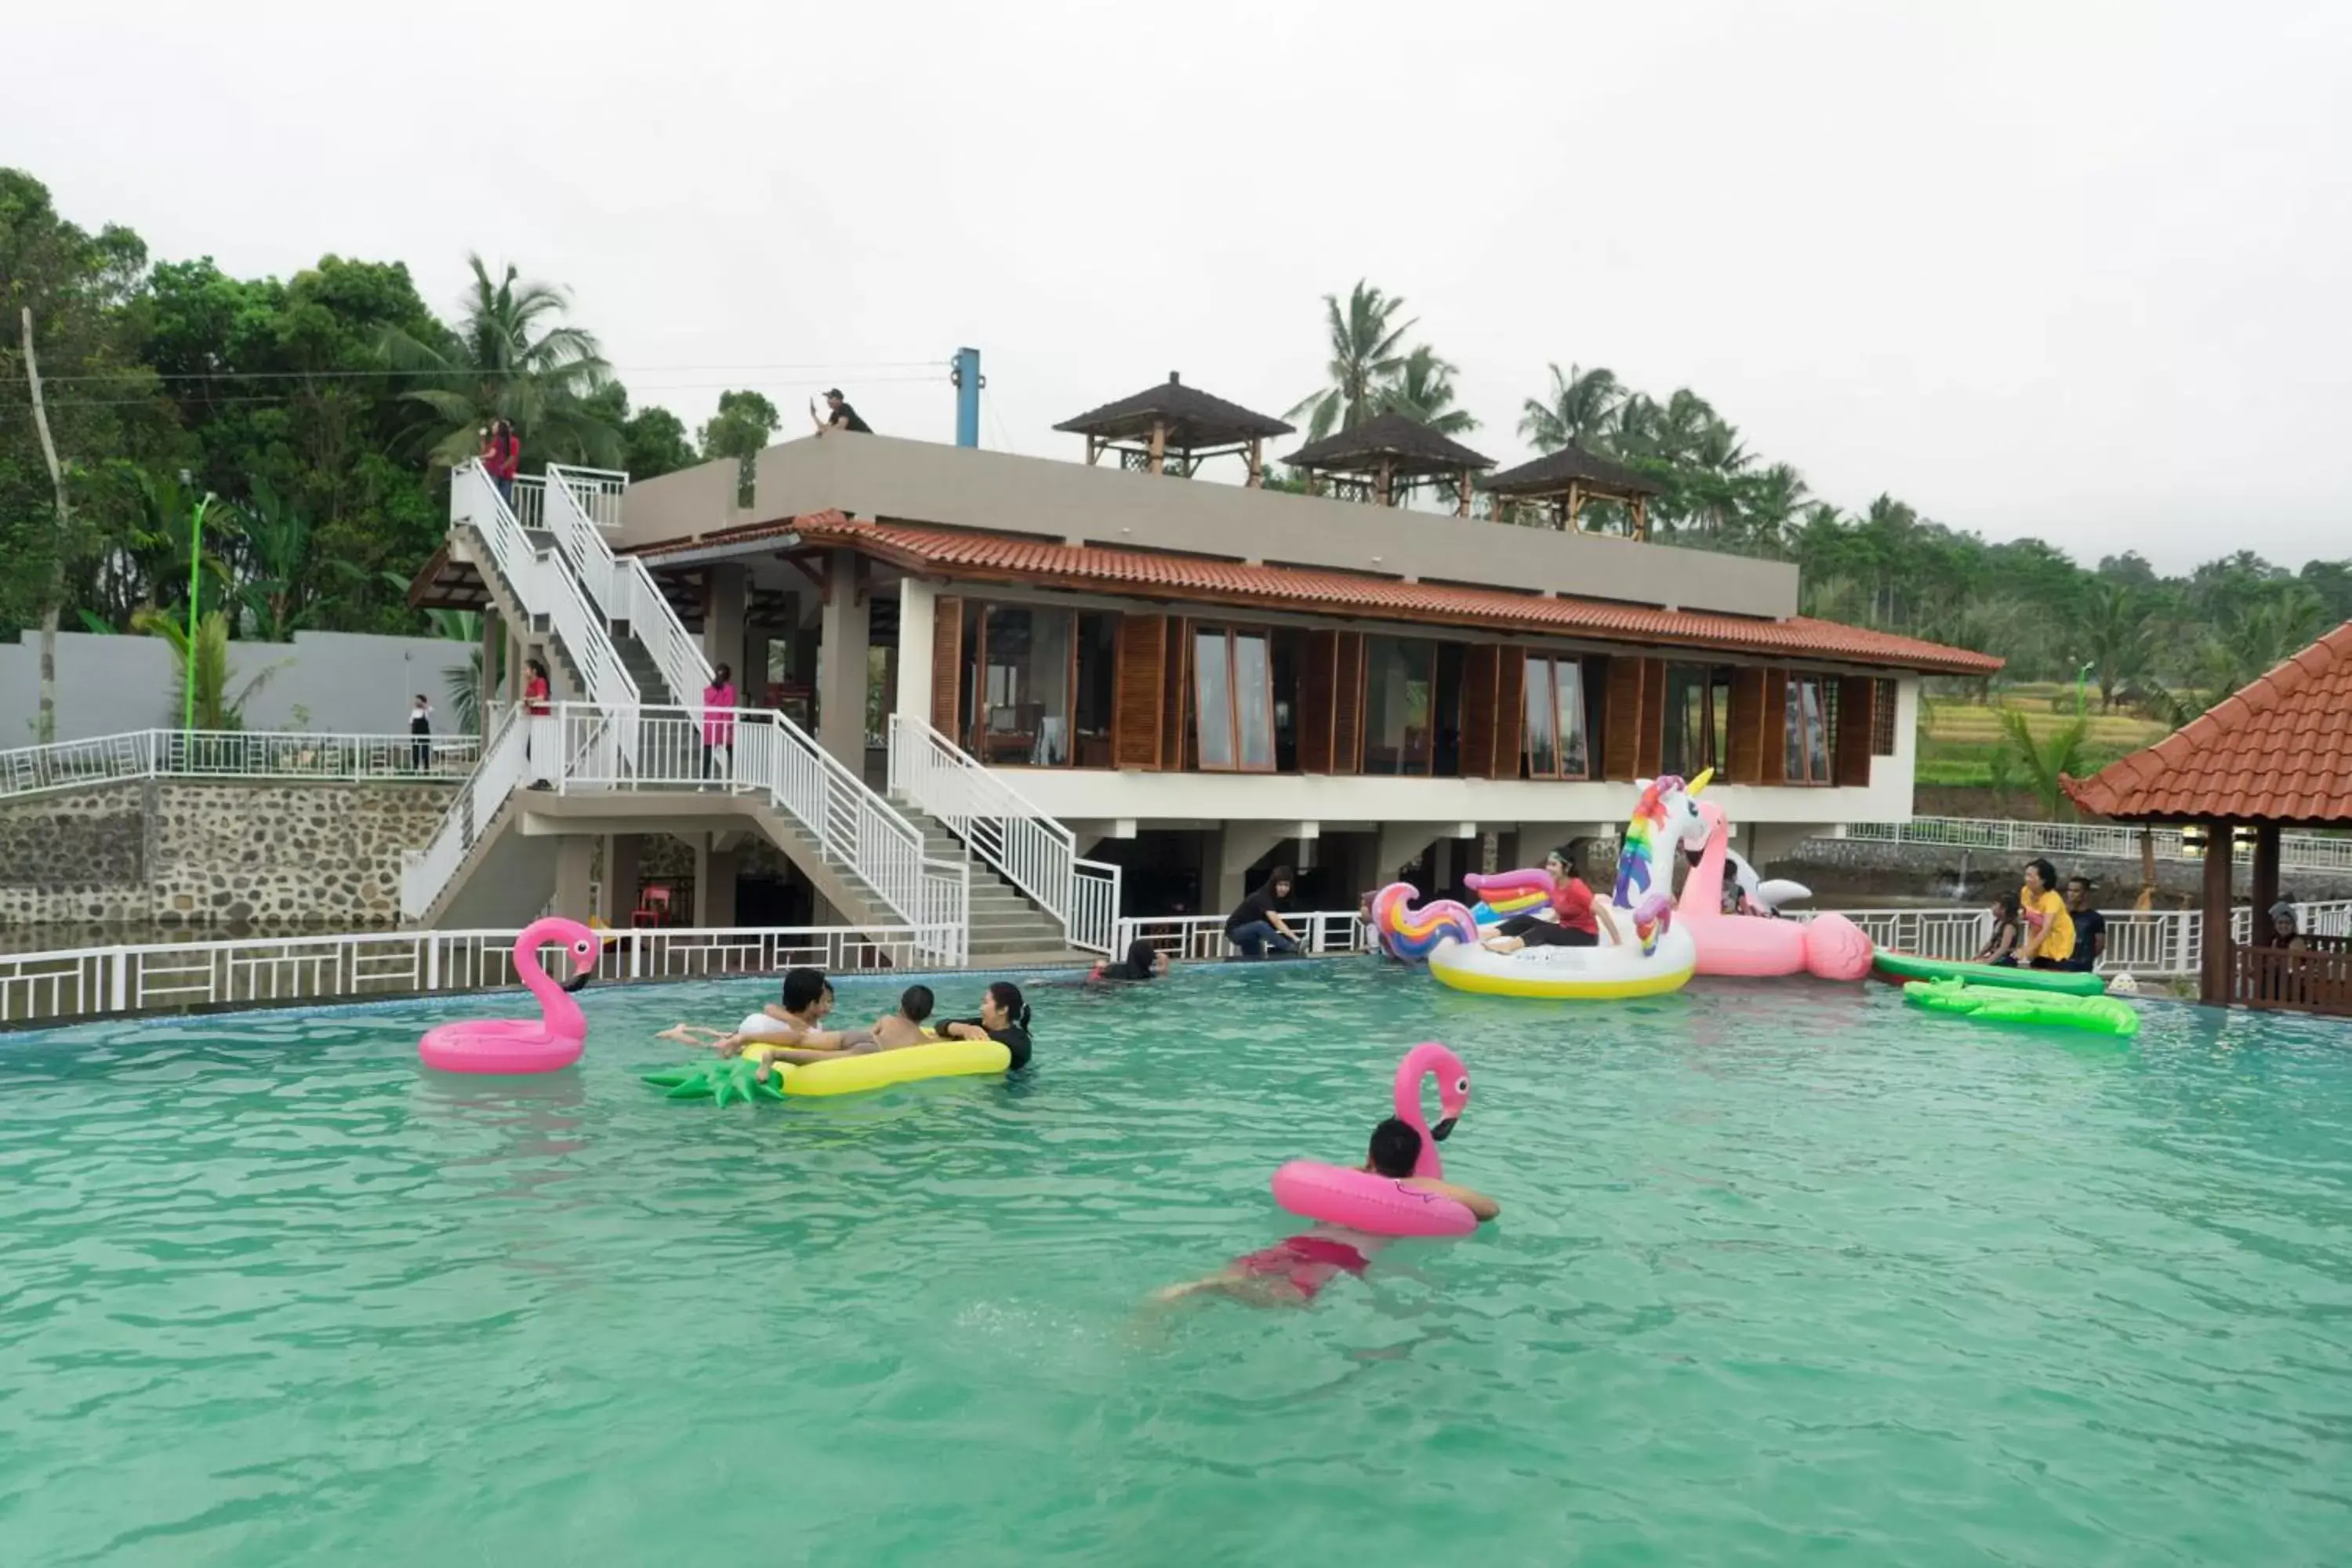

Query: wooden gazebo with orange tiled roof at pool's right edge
left=2060, top=621, right=2352, bottom=1018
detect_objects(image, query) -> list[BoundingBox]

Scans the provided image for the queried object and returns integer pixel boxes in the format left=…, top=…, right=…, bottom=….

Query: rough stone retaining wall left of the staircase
left=0, top=781, right=449, bottom=931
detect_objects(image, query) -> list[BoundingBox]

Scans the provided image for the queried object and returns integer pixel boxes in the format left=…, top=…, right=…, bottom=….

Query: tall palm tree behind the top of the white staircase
left=379, top=256, right=621, bottom=468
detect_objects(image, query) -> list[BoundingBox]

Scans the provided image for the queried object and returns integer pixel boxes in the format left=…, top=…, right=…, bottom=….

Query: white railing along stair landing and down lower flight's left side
left=550, top=703, right=971, bottom=961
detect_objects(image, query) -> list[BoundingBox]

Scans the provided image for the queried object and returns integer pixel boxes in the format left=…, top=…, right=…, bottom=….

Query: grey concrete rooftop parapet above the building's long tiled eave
left=621, top=435, right=1797, bottom=619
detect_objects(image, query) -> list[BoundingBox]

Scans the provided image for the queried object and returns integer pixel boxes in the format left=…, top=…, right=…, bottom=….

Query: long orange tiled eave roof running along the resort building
left=748, top=513, right=2002, bottom=675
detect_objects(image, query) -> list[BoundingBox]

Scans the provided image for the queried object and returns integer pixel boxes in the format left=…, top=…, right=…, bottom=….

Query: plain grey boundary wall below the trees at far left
left=0, top=633, right=475, bottom=750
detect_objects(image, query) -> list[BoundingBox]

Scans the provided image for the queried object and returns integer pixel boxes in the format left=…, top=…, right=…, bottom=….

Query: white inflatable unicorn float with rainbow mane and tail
left=1374, top=774, right=1708, bottom=1001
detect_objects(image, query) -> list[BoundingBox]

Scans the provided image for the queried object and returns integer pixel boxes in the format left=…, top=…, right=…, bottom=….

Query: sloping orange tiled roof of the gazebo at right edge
left=2063, top=621, right=2352, bottom=822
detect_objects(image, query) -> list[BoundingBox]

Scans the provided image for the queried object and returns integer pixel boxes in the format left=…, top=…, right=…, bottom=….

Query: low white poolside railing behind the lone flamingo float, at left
left=0, top=926, right=948, bottom=1025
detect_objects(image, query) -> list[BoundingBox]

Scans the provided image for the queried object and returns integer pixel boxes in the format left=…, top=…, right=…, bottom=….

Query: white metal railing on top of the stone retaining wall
left=0, top=729, right=480, bottom=799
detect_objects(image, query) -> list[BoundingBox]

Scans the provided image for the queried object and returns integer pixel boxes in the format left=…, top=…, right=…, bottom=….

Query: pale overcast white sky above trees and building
left=18, top=0, right=2352, bottom=569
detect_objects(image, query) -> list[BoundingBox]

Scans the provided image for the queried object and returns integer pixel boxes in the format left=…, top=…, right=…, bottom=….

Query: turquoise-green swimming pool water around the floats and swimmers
left=0, top=959, right=2352, bottom=1568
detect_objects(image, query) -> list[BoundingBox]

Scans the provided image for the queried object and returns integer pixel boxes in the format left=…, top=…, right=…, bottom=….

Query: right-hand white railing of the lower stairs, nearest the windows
left=889, top=713, right=1120, bottom=952
